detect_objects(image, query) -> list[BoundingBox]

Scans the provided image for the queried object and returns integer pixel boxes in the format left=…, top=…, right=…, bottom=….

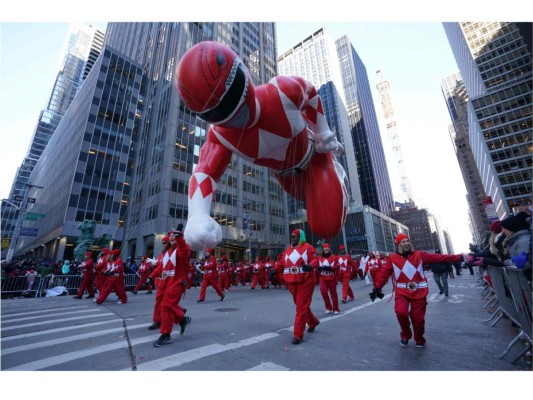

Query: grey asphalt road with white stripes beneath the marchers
left=1, top=271, right=531, bottom=398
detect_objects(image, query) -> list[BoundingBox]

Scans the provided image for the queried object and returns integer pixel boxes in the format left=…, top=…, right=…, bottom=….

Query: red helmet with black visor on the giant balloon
left=176, top=41, right=255, bottom=127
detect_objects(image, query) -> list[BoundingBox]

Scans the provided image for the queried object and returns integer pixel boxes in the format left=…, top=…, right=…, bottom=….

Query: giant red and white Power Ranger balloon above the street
left=176, top=41, right=347, bottom=251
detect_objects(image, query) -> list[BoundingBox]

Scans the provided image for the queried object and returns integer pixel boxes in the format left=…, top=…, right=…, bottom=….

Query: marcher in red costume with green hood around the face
left=281, top=229, right=320, bottom=344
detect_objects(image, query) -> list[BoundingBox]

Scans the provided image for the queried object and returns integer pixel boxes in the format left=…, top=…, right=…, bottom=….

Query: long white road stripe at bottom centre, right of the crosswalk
left=133, top=333, right=279, bottom=371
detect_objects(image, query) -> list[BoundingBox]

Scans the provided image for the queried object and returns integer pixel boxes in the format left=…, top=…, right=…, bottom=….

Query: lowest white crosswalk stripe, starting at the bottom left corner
left=4, top=335, right=154, bottom=371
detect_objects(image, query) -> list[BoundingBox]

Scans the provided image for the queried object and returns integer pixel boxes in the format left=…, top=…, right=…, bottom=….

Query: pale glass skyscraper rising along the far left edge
left=2, top=23, right=105, bottom=260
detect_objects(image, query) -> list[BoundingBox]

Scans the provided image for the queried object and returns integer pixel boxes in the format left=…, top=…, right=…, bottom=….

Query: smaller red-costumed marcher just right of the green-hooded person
left=318, top=243, right=340, bottom=314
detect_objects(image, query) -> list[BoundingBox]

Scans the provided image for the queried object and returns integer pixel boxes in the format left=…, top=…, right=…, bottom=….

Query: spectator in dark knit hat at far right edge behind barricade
left=501, top=211, right=532, bottom=280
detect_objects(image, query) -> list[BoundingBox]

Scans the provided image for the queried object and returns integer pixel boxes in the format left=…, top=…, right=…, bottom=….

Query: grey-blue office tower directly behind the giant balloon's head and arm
left=101, top=22, right=280, bottom=259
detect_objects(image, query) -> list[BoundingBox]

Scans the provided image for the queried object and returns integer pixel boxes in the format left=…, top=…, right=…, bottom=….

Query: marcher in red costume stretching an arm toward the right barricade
left=370, top=233, right=464, bottom=348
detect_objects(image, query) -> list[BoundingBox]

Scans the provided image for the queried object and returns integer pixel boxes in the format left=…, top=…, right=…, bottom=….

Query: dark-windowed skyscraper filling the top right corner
left=443, top=22, right=533, bottom=218
